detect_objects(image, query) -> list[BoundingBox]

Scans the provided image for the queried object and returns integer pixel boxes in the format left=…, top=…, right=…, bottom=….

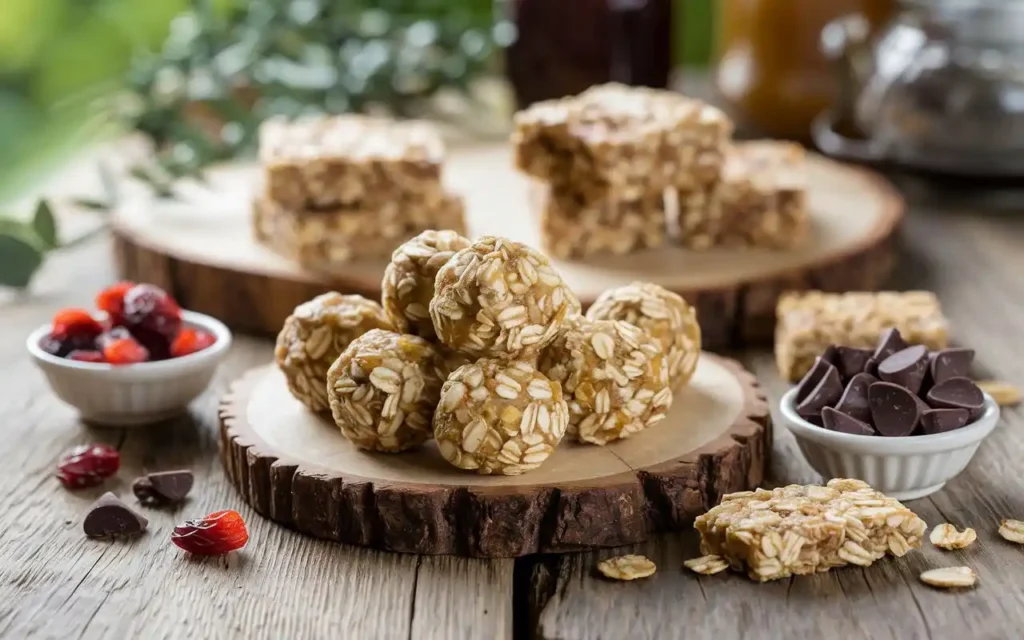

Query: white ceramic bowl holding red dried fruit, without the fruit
left=27, top=311, right=231, bottom=427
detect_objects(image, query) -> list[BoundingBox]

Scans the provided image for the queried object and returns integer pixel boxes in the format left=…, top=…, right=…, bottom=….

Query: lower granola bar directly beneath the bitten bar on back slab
left=541, top=188, right=666, bottom=259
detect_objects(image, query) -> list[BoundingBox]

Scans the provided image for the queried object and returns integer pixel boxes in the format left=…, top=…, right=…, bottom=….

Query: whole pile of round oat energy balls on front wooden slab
left=275, top=230, right=700, bottom=475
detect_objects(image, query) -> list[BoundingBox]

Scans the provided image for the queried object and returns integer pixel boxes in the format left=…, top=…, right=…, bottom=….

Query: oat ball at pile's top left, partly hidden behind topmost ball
left=381, top=230, right=470, bottom=340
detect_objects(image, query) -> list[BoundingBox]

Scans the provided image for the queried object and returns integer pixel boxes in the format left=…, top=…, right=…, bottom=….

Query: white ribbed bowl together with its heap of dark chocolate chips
left=780, top=329, right=999, bottom=500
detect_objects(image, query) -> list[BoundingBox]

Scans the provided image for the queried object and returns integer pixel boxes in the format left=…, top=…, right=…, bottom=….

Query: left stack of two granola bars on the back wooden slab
left=253, top=115, right=465, bottom=270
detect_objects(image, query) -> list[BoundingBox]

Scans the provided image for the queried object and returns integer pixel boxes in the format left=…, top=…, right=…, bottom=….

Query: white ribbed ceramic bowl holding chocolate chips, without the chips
left=780, top=388, right=999, bottom=500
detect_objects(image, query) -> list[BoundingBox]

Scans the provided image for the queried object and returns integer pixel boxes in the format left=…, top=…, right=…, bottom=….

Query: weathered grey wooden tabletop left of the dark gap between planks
left=0, top=241, right=513, bottom=640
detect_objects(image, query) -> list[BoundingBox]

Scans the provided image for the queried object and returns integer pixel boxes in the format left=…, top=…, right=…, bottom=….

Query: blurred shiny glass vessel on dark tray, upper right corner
left=815, top=0, right=1024, bottom=177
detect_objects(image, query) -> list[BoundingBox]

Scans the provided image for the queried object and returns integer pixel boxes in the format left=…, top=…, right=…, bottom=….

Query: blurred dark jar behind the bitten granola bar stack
left=498, top=0, right=674, bottom=109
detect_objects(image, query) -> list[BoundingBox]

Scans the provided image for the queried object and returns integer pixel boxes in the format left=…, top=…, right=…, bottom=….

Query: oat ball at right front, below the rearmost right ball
left=540, top=318, right=672, bottom=444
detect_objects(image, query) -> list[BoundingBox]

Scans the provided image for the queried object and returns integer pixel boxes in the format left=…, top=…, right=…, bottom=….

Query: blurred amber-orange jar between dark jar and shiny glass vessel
left=715, top=0, right=896, bottom=140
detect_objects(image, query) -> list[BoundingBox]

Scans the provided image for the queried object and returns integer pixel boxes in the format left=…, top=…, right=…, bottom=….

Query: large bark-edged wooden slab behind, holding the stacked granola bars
left=114, top=143, right=903, bottom=349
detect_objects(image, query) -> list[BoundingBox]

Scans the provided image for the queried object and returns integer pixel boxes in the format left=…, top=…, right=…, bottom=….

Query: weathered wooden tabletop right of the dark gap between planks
left=531, top=197, right=1024, bottom=640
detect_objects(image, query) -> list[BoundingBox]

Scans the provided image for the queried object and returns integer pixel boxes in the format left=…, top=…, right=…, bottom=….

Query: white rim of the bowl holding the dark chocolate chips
left=779, top=387, right=999, bottom=456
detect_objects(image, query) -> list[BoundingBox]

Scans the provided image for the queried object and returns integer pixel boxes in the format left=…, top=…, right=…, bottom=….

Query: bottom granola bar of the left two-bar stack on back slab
left=253, top=196, right=466, bottom=270
